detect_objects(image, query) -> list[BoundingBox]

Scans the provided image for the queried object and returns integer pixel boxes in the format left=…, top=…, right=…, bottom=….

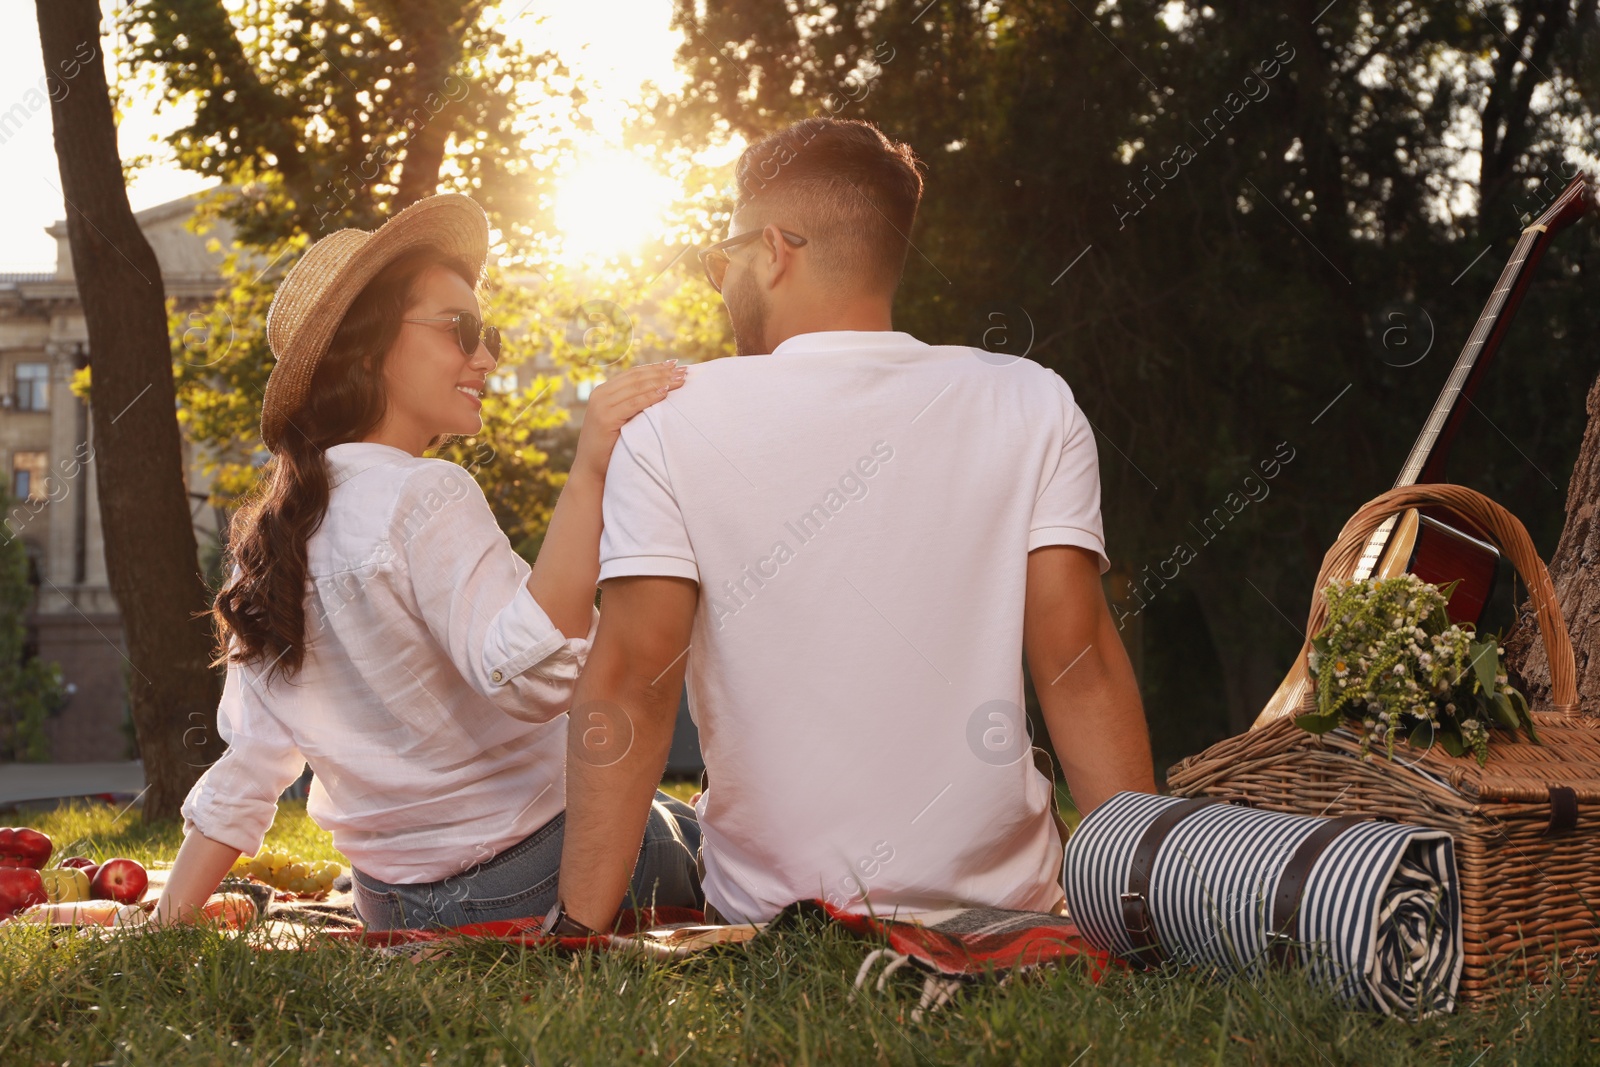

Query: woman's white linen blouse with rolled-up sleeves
left=182, top=442, right=600, bottom=885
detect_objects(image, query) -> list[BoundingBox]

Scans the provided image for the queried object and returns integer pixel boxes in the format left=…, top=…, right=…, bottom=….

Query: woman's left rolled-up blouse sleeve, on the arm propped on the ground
left=181, top=664, right=306, bottom=856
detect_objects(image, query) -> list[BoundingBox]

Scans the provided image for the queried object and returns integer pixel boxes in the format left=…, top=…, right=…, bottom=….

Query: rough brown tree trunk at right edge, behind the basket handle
left=1506, top=378, right=1600, bottom=709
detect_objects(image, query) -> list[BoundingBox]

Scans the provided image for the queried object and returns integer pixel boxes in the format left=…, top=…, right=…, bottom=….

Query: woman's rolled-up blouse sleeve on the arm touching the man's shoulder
left=389, top=461, right=600, bottom=723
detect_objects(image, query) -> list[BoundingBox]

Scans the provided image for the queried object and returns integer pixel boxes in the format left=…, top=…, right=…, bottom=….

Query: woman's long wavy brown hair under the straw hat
left=211, top=248, right=477, bottom=683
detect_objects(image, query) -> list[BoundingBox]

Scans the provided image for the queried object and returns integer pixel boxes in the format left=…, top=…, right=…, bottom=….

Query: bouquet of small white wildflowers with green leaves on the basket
left=1294, top=574, right=1539, bottom=766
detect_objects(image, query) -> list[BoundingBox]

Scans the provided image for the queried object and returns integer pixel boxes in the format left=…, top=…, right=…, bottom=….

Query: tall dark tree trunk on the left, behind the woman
left=37, top=0, right=222, bottom=819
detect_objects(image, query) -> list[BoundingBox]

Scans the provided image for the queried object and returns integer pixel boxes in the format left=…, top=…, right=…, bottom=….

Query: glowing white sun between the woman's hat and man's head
left=555, top=149, right=677, bottom=259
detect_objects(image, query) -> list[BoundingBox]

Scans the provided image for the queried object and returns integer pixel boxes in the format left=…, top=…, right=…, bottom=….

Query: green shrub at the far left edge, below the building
left=0, top=488, right=67, bottom=763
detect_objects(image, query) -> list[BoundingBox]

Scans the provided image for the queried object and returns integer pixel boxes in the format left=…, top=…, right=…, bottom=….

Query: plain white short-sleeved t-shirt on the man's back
left=600, top=331, right=1109, bottom=921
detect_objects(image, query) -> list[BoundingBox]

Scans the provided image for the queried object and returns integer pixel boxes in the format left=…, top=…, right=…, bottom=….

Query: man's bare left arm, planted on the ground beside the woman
left=560, top=576, right=699, bottom=929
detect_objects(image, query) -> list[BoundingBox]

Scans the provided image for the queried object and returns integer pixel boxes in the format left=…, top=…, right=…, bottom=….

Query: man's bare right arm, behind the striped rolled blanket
left=1022, top=545, right=1157, bottom=814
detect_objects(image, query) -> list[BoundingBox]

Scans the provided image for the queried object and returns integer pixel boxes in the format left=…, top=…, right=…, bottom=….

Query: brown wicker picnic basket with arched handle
left=1166, top=485, right=1600, bottom=1005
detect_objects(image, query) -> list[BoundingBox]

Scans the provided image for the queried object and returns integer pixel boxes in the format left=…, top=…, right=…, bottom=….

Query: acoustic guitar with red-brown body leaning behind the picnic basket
left=1251, top=174, right=1594, bottom=729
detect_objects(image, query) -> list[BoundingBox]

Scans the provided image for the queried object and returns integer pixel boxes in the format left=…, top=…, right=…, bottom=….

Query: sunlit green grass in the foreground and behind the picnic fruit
left=0, top=805, right=1600, bottom=1067
